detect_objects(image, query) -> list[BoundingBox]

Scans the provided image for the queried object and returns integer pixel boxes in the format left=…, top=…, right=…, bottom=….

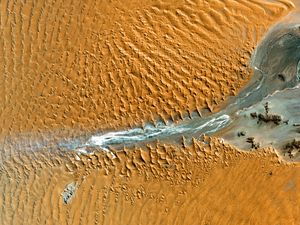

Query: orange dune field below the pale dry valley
left=0, top=139, right=300, bottom=225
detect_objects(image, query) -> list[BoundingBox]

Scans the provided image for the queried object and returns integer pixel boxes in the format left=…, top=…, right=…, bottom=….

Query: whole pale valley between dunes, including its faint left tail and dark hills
left=8, top=16, right=300, bottom=160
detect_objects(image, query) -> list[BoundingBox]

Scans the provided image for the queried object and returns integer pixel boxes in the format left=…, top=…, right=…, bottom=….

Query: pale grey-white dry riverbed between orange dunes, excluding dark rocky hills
left=57, top=13, right=300, bottom=160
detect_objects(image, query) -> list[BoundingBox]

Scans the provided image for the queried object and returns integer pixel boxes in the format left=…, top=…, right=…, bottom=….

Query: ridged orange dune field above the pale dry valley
left=0, top=0, right=293, bottom=134
